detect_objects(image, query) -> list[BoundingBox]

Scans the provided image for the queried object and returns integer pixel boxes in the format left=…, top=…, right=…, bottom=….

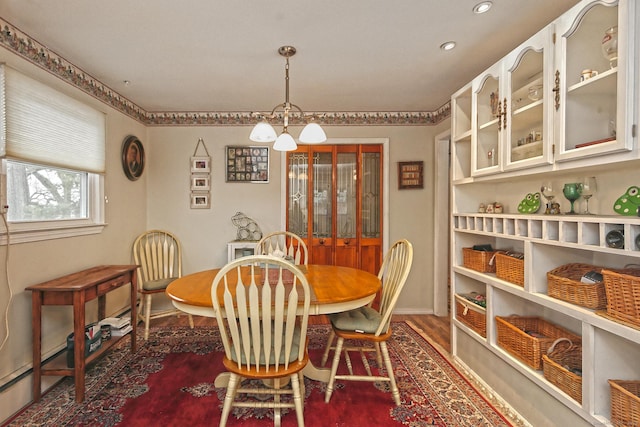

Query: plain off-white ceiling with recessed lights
left=0, top=0, right=578, bottom=112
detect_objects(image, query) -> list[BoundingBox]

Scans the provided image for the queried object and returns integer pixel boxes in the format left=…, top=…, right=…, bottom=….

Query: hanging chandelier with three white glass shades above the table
left=249, top=46, right=327, bottom=151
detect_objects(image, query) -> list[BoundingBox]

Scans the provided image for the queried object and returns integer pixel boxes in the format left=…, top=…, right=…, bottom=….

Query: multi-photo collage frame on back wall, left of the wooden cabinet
left=225, top=145, right=269, bottom=183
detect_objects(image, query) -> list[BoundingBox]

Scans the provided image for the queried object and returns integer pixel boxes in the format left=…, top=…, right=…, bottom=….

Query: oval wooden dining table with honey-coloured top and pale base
left=166, top=264, right=382, bottom=387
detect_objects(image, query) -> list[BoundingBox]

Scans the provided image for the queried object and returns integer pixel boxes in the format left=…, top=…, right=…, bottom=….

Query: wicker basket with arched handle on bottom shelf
left=542, top=338, right=582, bottom=404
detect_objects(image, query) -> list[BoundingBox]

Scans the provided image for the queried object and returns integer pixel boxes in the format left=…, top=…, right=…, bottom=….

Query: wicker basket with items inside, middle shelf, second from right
left=547, top=264, right=607, bottom=310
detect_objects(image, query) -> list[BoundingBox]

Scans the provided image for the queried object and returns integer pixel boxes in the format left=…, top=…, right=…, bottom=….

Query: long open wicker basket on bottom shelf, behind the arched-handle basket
left=496, top=316, right=582, bottom=371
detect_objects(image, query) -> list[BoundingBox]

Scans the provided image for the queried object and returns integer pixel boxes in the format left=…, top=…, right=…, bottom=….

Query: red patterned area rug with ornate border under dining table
left=6, top=322, right=512, bottom=427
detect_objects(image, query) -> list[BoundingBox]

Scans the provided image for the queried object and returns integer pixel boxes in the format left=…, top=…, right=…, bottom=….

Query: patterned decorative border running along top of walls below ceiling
left=0, top=18, right=451, bottom=126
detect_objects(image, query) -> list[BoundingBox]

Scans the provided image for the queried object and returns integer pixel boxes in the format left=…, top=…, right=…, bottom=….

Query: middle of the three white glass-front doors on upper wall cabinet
left=503, top=28, right=553, bottom=170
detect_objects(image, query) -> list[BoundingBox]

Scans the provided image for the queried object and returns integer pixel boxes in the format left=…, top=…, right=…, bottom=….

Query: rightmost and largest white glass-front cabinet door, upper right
left=555, top=0, right=635, bottom=161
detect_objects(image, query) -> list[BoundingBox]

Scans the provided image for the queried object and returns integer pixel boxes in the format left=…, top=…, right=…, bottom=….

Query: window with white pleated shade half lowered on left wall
left=0, top=66, right=105, bottom=242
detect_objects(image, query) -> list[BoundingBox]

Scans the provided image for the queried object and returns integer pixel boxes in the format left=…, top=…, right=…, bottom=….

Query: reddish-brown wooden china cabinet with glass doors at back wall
left=286, top=145, right=383, bottom=274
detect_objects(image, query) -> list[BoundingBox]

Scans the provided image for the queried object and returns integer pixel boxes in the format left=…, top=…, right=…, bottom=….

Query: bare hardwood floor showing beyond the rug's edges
left=151, top=314, right=451, bottom=352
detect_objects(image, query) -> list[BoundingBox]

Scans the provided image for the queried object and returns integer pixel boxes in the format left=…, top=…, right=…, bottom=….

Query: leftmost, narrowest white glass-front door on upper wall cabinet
left=472, top=67, right=506, bottom=175
